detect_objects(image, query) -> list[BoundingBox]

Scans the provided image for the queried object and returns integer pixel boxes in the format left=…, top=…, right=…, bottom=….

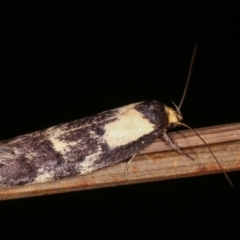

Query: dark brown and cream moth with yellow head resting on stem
left=0, top=48, right=232, bottom=186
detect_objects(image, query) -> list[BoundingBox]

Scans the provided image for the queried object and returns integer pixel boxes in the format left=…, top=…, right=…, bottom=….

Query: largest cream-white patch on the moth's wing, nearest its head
left=103, top=103, right=155, bottom=148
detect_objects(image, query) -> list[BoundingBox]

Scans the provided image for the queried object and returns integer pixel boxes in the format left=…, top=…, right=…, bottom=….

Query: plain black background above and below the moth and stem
left=0, top=1, right=240, bottom=239
